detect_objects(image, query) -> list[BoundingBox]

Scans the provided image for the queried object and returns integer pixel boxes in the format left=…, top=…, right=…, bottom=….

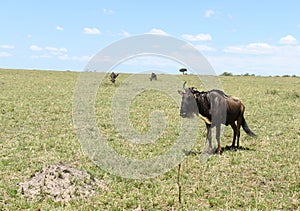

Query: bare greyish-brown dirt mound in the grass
left=19, top=163, right=108, bottom=201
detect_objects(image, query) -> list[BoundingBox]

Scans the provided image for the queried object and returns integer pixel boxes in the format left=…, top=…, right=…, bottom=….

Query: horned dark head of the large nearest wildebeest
left=178, top=82, right=199, bottom=118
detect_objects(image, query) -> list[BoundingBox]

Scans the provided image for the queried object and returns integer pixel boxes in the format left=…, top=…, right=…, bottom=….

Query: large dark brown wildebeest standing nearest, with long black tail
left=178, top=82, right=256, bottom=154
